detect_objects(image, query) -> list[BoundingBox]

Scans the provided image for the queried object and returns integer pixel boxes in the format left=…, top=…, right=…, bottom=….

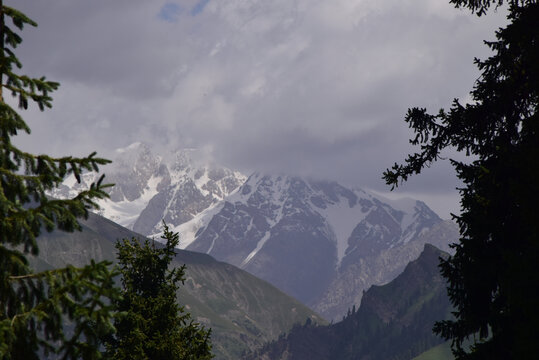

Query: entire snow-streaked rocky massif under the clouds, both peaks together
left=52, top=143, right=458, bottom=320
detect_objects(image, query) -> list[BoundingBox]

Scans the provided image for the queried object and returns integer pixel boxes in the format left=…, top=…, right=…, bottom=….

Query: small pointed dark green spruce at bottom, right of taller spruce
left=106, top=224, right=212, bottom=360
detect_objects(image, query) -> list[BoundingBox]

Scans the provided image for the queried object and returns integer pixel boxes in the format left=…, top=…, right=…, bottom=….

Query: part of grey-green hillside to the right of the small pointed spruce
left=179, top=258, right=326, bottom=359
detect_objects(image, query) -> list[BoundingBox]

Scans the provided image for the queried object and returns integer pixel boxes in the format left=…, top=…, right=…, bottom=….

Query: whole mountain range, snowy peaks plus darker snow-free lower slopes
left=40, top=143, right=458, bottom=359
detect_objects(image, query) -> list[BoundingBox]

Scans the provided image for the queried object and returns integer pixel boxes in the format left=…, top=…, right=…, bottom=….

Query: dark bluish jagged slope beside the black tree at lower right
left=245, top=244, right=451, bottom=360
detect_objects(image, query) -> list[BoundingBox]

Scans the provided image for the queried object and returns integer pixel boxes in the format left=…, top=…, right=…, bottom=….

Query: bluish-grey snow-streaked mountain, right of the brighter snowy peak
left=187, top=174, right=454, bottom=317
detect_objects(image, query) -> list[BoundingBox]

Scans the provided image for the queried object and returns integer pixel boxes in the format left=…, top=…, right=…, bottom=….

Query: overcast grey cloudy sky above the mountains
left=10, top=0, right=505, bottom=218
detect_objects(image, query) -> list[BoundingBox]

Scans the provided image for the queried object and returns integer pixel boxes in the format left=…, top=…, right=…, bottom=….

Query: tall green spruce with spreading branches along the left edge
left=0, top=0, right=118, bottom=360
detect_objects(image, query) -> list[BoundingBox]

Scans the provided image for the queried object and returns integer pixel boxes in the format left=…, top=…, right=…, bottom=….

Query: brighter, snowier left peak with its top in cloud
left=51, top=143, right=246, bottom=241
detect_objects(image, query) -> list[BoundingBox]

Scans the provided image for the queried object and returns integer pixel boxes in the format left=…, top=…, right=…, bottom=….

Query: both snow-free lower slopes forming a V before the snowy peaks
left=32, top=214, right=452, bottom=360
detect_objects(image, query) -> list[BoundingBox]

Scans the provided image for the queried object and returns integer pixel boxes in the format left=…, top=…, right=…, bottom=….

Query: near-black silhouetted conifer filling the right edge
left=384, top=0, right=539, bottom=359
